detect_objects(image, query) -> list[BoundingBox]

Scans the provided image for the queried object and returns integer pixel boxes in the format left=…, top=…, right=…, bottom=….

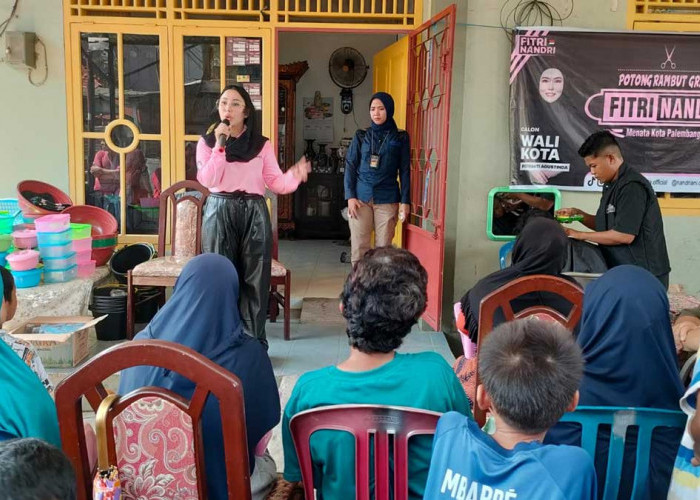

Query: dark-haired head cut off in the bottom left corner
left=0, top=438, right=76, bottom=500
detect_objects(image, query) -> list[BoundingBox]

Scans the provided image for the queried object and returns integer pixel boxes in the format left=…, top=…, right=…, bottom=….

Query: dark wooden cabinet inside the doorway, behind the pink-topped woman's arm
left=277, top=61, right=309, bottom=237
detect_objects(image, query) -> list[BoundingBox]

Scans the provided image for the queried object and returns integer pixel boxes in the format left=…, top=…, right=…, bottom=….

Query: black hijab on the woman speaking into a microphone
left=202, top=85, right=267, bottom=163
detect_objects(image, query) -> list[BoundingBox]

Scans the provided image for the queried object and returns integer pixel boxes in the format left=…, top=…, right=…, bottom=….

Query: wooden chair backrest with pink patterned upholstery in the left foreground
left=56, top=340, right=250, bottom=500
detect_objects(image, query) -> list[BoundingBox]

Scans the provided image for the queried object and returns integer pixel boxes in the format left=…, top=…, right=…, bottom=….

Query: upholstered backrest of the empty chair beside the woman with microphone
left=158, top=181, right=209, bottom=257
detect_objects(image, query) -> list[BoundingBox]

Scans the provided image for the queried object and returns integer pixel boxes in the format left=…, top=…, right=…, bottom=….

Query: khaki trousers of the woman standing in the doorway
left=349, top=202, right=399, bottom=266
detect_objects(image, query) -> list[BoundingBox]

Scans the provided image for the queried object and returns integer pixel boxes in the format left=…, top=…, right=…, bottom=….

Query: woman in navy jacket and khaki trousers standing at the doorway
left=345, top=92, right=411, bottom=265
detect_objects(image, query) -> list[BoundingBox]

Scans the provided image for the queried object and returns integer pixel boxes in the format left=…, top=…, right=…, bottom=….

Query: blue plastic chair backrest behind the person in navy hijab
left=561, top=406, right=687, bottom=500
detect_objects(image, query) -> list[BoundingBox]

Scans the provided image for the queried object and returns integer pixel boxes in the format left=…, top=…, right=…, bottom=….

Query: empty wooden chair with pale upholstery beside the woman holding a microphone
left=126, top=181, right=209, bottom=339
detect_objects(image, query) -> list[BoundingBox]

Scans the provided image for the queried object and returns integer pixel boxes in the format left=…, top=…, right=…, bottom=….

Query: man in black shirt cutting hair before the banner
left=558, top=131, right=671, bottom=289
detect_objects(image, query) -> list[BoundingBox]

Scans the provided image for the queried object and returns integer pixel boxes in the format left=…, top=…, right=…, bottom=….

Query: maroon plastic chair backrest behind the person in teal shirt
left=289, top=405, right=441, bottom=500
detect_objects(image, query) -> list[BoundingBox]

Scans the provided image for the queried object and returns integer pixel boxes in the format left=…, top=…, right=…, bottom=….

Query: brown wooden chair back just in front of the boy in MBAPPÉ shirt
left=474, top=274, right=583, bottom=426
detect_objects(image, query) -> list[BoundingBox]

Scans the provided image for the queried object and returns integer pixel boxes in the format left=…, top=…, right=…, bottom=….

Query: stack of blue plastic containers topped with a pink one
left=35, top=214, right=78, bottom=283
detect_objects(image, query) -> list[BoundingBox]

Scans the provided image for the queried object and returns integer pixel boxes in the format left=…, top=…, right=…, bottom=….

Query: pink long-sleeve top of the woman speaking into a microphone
left=197, top=138, right=299, bottom=196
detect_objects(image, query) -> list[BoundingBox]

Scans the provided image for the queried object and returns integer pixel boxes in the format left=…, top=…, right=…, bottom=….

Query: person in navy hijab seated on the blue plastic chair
left=545, top=265, right=683, bottom=499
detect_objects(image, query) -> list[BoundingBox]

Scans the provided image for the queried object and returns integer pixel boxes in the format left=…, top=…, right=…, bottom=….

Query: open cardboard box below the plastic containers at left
left=8, top=315, right=107, bottom=368
